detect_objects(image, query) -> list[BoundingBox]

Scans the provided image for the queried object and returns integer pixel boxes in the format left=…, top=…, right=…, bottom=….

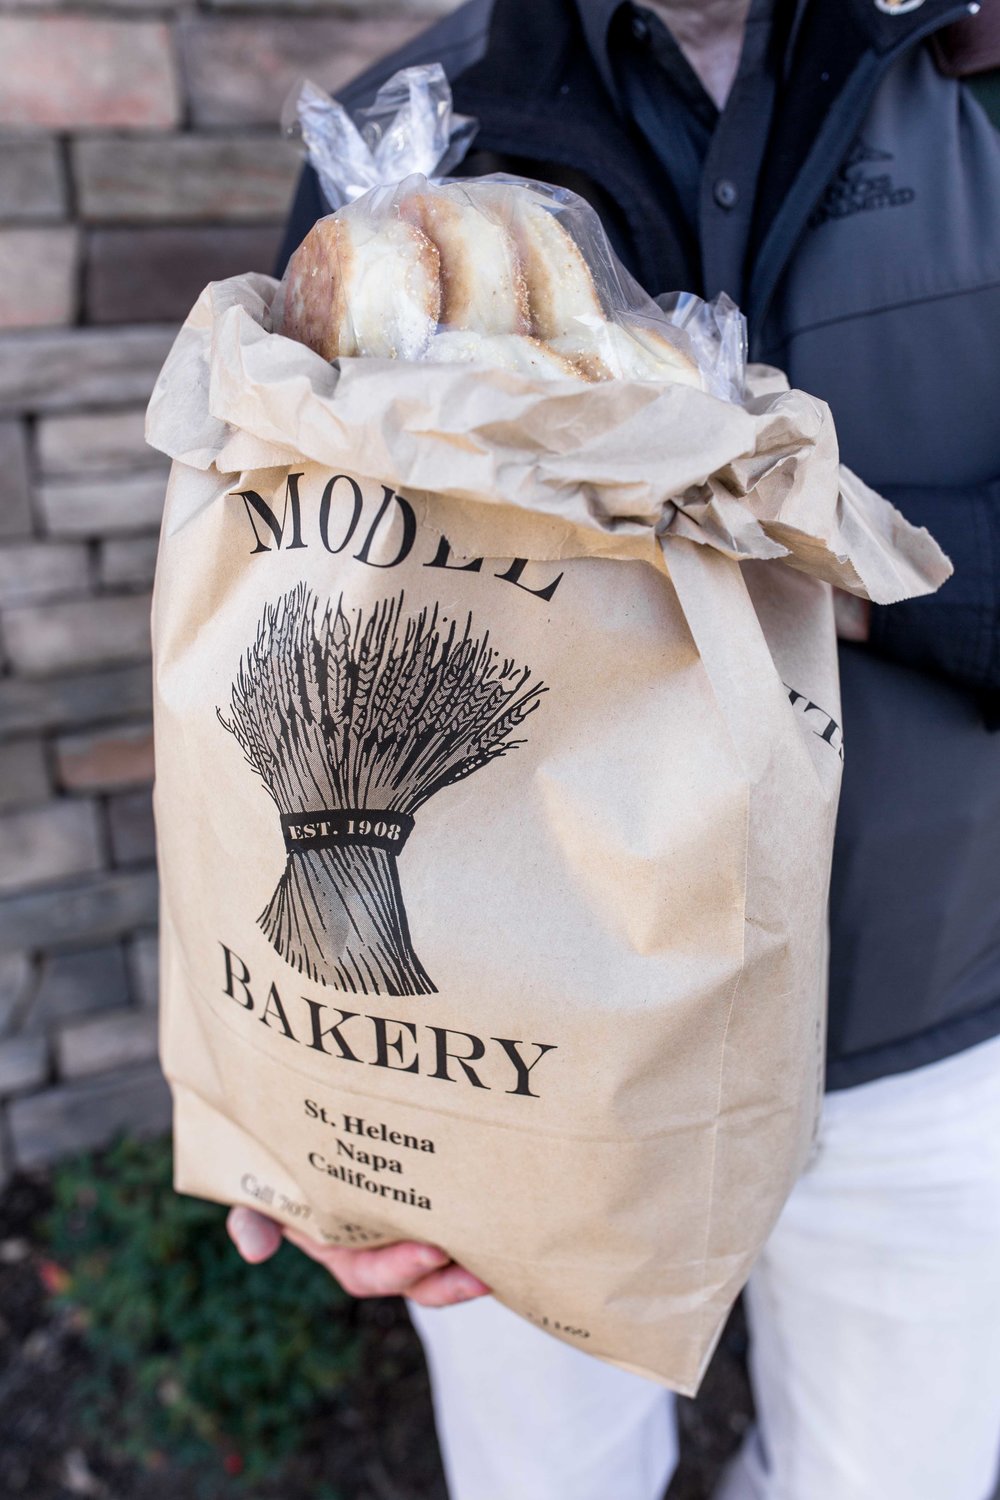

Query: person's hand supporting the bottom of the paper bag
left=226, top=1208, right=489, bottom=1308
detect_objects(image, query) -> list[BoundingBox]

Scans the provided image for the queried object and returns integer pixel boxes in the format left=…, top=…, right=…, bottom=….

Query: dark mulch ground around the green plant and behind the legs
left=0, top=1178, right=750, bottom=1500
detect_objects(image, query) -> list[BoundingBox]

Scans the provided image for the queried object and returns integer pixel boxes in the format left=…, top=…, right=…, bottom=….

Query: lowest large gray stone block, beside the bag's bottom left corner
left=7, top=1065, right=171, bottom=1170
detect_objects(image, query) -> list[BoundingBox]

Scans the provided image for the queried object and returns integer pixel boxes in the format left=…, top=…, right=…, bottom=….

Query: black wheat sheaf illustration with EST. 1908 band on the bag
left=217, top=584, right=547, bottom=995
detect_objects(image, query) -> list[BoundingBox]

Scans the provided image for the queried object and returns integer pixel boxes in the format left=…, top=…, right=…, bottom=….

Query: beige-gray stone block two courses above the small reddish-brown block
left=3, top=594, right=150, bottom=677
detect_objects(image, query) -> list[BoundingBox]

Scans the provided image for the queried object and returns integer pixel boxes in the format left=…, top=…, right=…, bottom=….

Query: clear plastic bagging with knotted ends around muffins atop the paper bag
left=273, top=65, right=747, bottom=401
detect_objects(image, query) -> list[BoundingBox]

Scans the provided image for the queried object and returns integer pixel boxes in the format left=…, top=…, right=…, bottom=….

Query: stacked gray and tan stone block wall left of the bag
left=0, top=0, right=448, bottom=1181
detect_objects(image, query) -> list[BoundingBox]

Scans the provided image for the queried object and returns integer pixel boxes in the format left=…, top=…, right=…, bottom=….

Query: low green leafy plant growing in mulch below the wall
left=46, top=1140, right=358, bottom=1493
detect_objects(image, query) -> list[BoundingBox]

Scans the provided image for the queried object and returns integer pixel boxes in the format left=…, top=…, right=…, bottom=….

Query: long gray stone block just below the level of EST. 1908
left=0, top=870, right=157, bottom=951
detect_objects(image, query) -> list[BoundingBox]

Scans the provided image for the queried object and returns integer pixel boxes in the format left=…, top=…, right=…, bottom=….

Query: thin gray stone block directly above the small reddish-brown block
left=0, top=665, right=153, bottom=735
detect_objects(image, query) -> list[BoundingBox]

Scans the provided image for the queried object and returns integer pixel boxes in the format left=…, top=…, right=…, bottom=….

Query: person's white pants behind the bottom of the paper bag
left=411, top=1040, right=1000, bottom=1500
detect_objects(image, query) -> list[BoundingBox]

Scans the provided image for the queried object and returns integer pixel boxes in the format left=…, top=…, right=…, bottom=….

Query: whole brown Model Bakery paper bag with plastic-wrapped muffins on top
left=148, top=69, right=949, bottom=1392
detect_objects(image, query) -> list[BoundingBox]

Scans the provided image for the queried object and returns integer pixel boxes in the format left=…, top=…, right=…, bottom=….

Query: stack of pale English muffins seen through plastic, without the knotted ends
left=276, top=177, right=705, bottom=389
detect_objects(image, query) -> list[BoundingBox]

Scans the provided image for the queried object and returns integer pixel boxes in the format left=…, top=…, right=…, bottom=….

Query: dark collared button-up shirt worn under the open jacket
left=577, top=0, right=790, bottom=302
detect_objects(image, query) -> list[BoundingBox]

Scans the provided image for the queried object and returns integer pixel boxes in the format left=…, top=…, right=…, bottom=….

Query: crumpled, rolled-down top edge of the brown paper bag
left=145, top=275, right=952, bottom=605
